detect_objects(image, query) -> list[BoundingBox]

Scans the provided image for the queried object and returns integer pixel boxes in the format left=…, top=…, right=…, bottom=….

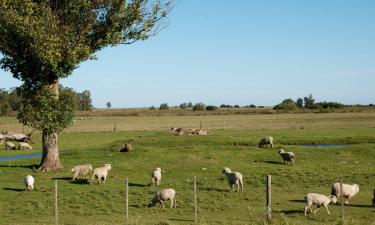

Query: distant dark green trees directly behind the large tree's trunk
left=0, top=85, right=93, bottom=116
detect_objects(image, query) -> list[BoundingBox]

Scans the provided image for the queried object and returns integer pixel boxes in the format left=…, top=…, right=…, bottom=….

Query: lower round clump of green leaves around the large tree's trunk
left=17, top=87, right=74, bottom=133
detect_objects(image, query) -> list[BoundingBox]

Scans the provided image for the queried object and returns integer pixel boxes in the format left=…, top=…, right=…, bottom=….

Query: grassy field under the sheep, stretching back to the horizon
left=0, top=113, right=375, bottom=225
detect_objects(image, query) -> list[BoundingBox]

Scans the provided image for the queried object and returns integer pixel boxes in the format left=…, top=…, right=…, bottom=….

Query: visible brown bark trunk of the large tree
left=38, top=79, right=63, bottom=172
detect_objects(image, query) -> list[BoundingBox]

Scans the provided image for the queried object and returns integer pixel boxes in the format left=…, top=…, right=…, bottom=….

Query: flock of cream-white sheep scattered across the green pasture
left=16, top=134, right=368, bottom=216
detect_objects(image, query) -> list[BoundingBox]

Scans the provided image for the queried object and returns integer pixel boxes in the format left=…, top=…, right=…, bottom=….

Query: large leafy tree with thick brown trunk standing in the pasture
left=0, top=0, right=171, bottom=171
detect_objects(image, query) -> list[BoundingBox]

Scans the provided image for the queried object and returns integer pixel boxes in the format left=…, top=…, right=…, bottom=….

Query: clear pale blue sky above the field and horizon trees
left=0, top=0, right=375, bottom=108
